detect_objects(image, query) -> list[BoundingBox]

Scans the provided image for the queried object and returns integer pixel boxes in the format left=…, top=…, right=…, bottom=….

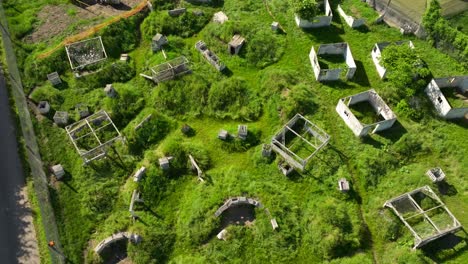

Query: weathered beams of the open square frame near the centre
left=271, top=114, right=330, bottom=171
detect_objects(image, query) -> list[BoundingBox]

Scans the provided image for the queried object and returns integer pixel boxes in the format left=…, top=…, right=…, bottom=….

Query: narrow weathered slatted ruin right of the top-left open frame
left=143, top=56, right=192, bottom=83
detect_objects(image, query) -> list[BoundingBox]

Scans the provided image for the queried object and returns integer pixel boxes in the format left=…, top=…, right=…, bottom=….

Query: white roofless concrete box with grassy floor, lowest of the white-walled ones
left=336, top=89, right=397, bottom=137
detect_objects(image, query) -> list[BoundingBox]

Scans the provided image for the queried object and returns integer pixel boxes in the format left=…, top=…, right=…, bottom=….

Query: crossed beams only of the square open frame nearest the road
left=65, top=110, right=122, bottom=164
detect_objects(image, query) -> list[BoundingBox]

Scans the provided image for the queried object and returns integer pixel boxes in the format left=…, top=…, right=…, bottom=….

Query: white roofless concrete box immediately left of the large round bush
left=309, top=42, right=356, bottom=82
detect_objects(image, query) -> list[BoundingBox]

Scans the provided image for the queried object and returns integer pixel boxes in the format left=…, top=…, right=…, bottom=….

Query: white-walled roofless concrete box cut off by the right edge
left=424, top=76, right=468, bottom=119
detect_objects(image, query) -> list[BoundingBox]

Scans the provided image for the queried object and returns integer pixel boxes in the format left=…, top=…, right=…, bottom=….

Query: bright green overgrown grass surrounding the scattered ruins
left=2, top=0, right=468, bottom=263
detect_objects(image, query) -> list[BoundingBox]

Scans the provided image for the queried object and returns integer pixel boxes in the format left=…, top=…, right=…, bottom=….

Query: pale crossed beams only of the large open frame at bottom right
left=384, top=185, right=462, bottom=249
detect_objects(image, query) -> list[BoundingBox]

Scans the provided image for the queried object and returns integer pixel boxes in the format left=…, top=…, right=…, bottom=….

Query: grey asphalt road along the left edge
left=0, top=71, right=37, bottom=264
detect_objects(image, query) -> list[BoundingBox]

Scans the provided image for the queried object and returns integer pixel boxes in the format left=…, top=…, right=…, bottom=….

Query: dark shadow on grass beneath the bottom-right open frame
left=421, top=230, right=468, bottom=263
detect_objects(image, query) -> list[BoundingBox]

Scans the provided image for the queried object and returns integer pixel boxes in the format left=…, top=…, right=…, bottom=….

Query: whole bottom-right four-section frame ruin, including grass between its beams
left=384, top=186, right=462, bottom=249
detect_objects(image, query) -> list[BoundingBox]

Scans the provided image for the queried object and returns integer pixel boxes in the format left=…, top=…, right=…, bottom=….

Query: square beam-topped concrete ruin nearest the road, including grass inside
left=65, top=110, right=122, bottom=164
